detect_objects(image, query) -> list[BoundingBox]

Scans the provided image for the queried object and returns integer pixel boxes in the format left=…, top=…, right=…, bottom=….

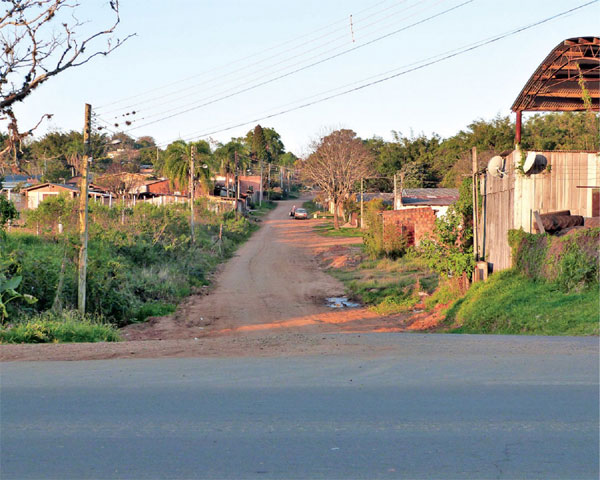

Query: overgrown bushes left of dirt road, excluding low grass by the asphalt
left=4, top=199, right=258, bottom=326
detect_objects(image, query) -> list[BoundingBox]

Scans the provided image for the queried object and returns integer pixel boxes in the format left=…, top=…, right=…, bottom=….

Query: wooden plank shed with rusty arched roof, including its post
left=478, top=37, right=600, bottom=271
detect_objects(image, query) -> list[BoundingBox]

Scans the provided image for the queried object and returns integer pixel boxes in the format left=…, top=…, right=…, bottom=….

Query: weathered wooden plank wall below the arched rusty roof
left=480, top=150, right=600, bottom=271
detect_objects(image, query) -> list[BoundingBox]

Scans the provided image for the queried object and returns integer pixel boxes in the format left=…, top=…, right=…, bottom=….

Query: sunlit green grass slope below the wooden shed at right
left=446, top=271, right=600, bottom=335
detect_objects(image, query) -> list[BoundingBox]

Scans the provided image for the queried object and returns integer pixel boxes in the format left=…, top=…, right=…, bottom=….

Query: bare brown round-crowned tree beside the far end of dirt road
left=302, top=130, right=374, bottom=229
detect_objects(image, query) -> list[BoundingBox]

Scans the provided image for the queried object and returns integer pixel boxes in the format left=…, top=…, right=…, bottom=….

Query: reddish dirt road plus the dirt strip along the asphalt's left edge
left=0, top=200, right=418, bottom=360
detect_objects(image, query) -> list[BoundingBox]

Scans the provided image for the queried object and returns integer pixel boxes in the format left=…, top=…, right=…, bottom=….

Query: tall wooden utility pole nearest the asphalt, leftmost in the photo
left=77, top=103, right=92, bottom=314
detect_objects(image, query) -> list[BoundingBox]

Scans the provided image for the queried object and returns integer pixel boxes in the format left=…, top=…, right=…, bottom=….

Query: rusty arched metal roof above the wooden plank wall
left=511, top=37, right=600, bottom=112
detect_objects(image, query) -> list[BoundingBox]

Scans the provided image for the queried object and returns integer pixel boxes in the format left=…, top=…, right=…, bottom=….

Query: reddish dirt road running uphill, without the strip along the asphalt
left=124, top=201, right=376, bottom=340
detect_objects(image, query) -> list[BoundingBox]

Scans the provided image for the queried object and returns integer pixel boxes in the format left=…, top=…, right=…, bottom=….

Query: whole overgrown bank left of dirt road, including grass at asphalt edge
left=0, top=202, right=262, bottom=342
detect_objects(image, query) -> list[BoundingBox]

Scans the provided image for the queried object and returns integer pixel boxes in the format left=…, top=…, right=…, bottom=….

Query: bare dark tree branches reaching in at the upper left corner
left=0, top=0, right=129, bottom=166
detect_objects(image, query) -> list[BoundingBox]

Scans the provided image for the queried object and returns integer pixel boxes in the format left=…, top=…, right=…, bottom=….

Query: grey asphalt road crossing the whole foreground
left=0, top=334, right=599, bottom=480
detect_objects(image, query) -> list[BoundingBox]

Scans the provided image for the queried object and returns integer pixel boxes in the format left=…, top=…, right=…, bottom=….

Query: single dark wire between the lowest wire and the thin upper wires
left=108, top=0, right=474, bottom=132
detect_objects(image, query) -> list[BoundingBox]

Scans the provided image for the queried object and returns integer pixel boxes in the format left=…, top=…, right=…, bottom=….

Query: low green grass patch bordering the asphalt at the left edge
left=0, top=312, right=121, bottom=343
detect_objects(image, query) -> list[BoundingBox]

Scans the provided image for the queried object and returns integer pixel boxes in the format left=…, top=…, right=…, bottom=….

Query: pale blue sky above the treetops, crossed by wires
left=10, top=0, right=600, bottom=154
